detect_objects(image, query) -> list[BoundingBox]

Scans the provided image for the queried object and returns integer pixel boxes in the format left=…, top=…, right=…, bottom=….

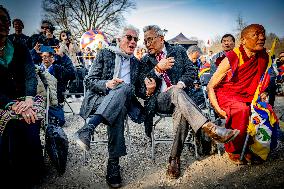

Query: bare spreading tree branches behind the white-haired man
left=42, top=0, right=136, bottom=37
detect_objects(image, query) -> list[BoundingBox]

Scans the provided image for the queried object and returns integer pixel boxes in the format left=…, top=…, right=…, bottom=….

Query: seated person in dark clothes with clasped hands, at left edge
left=0, top=6, right=43, bottom=188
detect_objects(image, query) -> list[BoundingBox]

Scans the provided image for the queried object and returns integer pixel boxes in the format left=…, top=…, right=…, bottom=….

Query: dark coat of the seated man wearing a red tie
left=140, top=42, right=197, bottom=136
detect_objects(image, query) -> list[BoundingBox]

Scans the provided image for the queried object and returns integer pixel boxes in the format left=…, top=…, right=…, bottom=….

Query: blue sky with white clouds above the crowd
left=0, top=0, right=284, bottom=42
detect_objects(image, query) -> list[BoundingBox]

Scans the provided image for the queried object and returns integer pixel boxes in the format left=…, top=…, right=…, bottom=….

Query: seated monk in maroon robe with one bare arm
left=207, top=24, right=269, bottom=164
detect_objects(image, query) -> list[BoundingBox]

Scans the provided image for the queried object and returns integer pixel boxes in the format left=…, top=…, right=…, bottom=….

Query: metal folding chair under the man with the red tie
left=151, top=113, right=199, bottom=161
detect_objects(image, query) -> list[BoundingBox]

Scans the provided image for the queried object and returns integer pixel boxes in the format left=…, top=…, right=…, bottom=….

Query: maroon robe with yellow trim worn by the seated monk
left=215, top=46, right=269, bottom=153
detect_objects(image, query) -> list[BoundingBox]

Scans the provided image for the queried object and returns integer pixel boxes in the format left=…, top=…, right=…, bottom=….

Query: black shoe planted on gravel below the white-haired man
left=106, top=160, right=121, bottom=188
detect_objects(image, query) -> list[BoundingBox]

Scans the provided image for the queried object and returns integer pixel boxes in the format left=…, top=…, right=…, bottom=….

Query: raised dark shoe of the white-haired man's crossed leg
left=75, top=124, right=94, bottom=151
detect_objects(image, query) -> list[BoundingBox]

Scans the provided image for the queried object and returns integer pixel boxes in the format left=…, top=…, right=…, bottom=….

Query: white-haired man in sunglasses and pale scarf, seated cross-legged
left=75, top=26, right=141, bottom=188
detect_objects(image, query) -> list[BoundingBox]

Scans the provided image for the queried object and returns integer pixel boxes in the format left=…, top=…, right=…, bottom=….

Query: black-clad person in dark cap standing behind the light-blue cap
left=28, top=20, right=59, bottom=50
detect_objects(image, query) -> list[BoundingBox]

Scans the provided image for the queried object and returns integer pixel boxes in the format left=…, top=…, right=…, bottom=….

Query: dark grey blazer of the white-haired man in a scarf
left=80, top=49, right=140, bottom=119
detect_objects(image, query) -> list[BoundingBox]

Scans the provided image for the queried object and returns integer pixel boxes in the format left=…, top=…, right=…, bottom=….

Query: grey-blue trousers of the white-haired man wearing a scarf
left=95, top=83, right=131, bottom=158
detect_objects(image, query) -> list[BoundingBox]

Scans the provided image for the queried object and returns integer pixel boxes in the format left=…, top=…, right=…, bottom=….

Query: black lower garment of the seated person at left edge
left=0, top=120, right=43, bottom=188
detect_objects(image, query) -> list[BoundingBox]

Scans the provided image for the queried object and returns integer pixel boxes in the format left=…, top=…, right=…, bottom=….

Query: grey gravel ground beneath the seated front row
left=35, top=97, right=284, bottom=189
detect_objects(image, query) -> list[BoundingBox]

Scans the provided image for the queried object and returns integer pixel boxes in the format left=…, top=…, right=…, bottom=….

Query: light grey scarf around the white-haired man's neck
left=106, top=46, right=133, bottom=78
